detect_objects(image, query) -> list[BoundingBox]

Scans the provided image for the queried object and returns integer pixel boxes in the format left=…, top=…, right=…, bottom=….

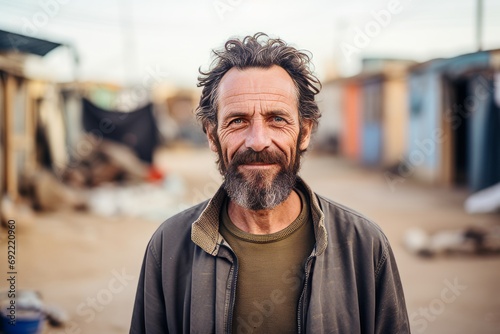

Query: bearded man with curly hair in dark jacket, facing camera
left=130, top=33, right=409, bottom=334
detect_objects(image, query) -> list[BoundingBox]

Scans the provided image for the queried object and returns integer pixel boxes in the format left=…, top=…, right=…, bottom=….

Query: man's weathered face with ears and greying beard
left=207, top=66, right=312, bottom=210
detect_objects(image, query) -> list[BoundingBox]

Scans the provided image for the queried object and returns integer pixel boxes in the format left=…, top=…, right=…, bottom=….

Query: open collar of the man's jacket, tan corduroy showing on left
left=191, top=177, right=327, bottom=256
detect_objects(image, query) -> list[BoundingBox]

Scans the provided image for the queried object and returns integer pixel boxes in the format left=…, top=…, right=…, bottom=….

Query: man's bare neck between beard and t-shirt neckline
left=228, top=190, right=301, bottom=234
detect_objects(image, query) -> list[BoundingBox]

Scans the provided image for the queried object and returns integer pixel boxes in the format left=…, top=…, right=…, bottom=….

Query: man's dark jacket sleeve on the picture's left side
left=130, top=242, right=168, bottom=334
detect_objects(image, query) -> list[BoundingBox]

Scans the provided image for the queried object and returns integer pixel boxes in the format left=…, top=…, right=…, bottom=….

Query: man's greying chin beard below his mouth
left=223, top=167, right=297, bottom=210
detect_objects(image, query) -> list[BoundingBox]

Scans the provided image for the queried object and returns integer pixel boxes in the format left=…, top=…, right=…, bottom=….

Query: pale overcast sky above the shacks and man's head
left=0, top=0, right=500, bottom=87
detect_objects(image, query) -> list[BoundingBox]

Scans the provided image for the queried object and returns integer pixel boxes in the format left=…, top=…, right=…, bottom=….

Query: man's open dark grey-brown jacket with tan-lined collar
left=130, top=181, right=410, bottom=334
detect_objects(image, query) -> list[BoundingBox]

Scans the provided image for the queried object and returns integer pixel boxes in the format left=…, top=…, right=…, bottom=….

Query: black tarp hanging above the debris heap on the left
left=83, top=99, right=158, bottom=163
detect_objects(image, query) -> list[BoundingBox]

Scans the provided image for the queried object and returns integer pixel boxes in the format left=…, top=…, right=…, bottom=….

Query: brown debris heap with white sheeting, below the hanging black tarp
left=16, top=136, right=189, bottom=221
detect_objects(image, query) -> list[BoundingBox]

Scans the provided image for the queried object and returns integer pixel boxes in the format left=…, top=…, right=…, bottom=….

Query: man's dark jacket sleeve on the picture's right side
left=375, top=241, right=410, bottom=334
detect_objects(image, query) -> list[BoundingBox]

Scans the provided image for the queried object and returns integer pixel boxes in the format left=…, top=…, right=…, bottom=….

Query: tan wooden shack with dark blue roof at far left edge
left=0, top=30, right=62, bottom=201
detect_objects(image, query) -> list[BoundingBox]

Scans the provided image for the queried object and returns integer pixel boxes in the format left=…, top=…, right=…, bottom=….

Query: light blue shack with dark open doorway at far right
left=402, top=50, right=500, bottom=191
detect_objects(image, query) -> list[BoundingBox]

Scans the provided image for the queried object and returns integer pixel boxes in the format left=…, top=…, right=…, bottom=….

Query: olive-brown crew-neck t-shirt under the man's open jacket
left=220, top=189, right=315, bottom=334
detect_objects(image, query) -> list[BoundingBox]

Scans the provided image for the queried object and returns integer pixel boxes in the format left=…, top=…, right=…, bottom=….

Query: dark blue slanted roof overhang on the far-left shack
left=0, top=30, right=62, bottom=56
